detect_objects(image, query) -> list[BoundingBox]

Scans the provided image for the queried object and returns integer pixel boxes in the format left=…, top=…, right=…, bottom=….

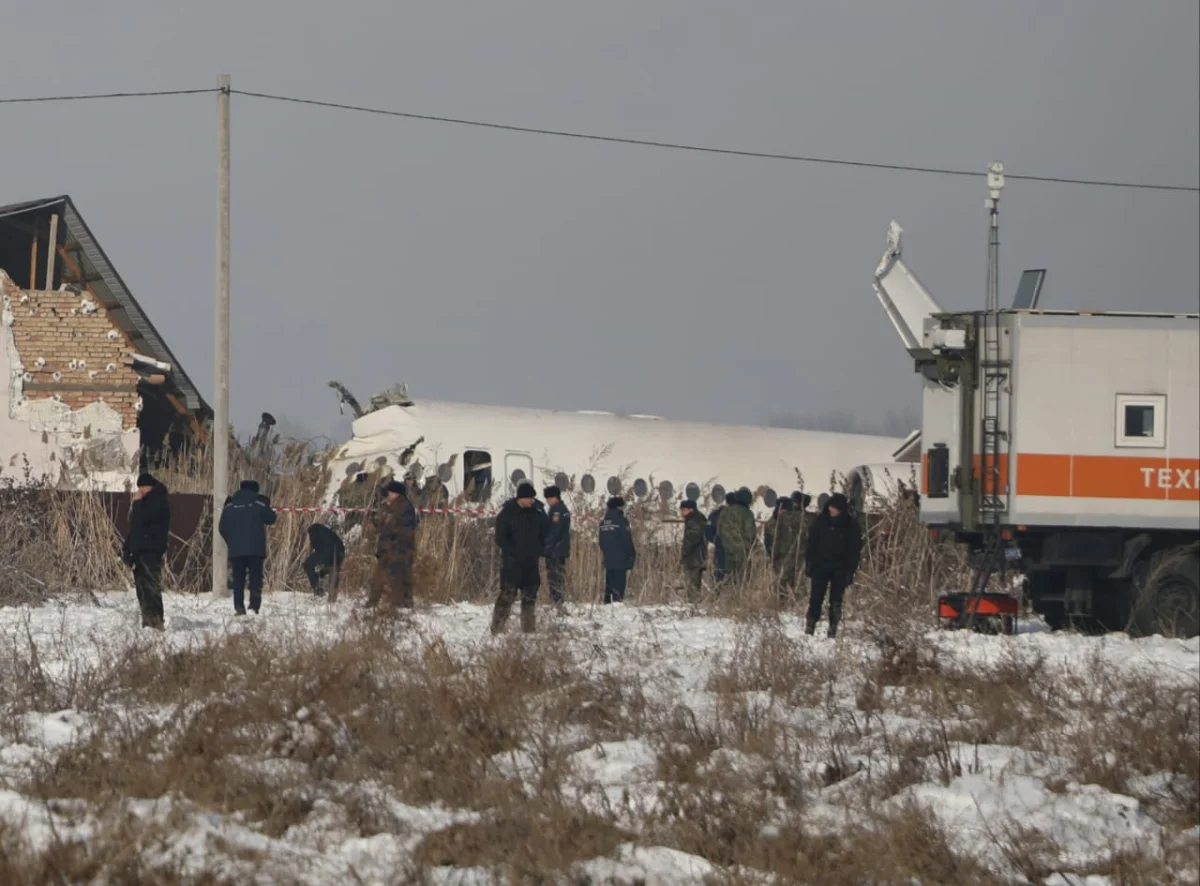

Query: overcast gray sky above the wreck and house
left=0, top=0, right=1200, bottom=433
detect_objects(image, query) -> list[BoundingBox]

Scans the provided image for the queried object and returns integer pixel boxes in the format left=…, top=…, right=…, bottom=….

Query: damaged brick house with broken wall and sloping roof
left=0, top=196, right=212, bottom=490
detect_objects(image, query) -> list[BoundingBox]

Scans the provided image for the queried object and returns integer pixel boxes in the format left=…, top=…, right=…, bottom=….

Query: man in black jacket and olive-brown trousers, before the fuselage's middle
left=492, top=483, right=550, bottom=634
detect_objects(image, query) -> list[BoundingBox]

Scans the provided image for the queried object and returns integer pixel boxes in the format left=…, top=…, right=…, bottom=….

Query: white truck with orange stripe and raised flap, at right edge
left=875, top=222, right=1200, bottom=636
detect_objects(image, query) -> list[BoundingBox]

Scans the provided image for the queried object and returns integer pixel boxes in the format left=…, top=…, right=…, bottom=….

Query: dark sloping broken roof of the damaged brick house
left=0, top=194, right=212, bottom=417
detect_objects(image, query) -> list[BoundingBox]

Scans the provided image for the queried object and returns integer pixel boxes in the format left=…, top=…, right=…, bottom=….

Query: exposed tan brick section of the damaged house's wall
left=4, top=279, right=140, bottom=430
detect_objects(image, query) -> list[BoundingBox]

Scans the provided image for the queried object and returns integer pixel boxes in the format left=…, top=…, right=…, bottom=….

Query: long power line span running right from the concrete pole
left=232, top=89, right=1200, bottom=193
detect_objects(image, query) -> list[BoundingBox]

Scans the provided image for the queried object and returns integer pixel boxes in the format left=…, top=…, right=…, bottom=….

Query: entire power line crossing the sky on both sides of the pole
left=0, top=88, right=1200, bottom=193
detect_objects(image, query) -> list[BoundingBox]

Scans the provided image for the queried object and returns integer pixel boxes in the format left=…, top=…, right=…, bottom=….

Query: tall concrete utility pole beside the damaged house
left=212, top=74, right=229, bottom=595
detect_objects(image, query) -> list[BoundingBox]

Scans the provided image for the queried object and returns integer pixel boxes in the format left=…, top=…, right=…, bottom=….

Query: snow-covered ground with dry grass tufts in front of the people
left=0, top=593, right=1200, bottom=886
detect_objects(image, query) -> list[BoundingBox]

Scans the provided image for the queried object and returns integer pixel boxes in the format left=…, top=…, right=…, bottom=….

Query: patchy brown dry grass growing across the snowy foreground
left=0, top=607, right=1200, bottom=886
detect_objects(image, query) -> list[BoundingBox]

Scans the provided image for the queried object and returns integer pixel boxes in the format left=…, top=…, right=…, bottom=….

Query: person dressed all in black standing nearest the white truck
left=804, top=492, right=863, bottom=636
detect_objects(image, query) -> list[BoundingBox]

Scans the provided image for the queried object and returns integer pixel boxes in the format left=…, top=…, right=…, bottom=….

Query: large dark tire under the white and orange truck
left=1130, top=545, right=1200, bottom=639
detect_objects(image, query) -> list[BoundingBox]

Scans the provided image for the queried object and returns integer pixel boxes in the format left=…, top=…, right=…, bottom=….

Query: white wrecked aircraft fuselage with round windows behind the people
left=328, top=400, right=919, bottom=516
